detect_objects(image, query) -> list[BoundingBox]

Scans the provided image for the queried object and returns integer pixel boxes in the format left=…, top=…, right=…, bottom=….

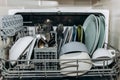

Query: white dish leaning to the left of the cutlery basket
left=9, top=36, right=34, bottom=65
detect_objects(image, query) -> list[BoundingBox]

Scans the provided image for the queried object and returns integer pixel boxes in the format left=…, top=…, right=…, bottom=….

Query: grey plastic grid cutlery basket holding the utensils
left=34, top=32, right=58, bottom=70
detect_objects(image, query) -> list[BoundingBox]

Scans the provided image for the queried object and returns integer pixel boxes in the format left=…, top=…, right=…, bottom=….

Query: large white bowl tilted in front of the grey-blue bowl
left=60, top=52, right=92, bottom=76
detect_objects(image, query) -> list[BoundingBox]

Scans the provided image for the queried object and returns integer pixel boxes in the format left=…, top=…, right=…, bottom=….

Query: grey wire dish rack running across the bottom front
left=0, top=54, right=120, bottom=80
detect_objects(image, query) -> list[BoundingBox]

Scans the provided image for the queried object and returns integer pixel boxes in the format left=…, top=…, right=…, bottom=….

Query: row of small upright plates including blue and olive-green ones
left=63, top=25, right=84, bottom=45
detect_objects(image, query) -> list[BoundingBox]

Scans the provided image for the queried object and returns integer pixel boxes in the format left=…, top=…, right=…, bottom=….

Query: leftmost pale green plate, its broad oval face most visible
left=83, top=14, right=98, bottom=53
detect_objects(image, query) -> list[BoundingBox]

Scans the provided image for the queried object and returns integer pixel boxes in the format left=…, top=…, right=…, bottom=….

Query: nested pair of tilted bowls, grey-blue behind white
left=59, top=42, right=92, bottom=76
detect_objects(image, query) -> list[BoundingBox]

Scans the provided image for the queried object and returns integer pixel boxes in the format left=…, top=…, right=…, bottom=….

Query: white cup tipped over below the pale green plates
left=92, top=48, right=115, bottom=66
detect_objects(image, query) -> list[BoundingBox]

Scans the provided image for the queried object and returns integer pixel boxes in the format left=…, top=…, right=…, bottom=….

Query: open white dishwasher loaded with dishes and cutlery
left=0, top=8, right=120, bottom=80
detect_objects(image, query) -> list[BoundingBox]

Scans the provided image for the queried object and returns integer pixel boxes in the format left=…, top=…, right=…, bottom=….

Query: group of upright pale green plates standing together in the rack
left=83, top=14, right=105, bottom=55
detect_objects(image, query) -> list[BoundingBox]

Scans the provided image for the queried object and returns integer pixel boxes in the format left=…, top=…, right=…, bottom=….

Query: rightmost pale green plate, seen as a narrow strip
left=97, top=16, right=105, bottom=48
